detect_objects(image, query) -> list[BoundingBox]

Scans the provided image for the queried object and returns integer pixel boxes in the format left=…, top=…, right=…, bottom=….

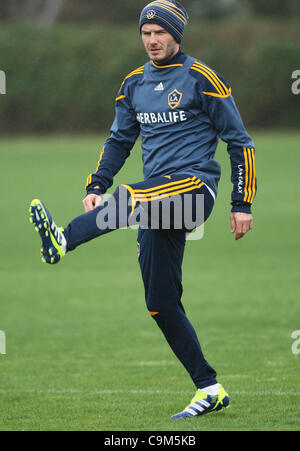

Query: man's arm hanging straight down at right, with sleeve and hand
left=202, top=76, right=257, bottom=240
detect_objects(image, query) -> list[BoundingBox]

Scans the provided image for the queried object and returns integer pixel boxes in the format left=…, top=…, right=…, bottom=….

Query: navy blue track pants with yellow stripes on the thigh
left=64, top=174, right=217, bottom=388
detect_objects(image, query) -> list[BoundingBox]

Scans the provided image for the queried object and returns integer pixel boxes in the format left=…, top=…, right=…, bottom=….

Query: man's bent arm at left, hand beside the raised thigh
left=83, top=85, right=140, bottom=211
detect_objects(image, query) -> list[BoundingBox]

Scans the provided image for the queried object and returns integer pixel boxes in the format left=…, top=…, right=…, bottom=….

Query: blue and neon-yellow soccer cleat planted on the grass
left=172, top=384, right=229, bottom=419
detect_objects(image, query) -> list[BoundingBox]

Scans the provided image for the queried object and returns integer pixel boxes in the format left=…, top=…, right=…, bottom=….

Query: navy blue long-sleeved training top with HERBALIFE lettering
left=86, top=50, right=256, bottom=212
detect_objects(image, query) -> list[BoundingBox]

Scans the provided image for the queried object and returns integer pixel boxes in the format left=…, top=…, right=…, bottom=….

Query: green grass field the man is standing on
left=0, top=132, right=300, bottom=431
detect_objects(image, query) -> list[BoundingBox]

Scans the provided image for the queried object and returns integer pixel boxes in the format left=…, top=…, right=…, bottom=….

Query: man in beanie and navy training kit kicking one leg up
left=30, top=0, right=256, bottom=418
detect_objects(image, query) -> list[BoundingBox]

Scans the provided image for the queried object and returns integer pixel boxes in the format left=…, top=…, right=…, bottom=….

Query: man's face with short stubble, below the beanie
left=142, top=23, right=179, bottom=64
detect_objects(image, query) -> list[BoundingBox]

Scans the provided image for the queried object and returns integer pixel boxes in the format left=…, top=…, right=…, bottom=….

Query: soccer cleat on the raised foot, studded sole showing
left=29, top=199, right=66, bottom=265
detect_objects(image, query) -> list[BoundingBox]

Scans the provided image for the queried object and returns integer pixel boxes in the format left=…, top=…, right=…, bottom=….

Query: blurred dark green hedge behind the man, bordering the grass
left=0, top=20, right=300, bottom=134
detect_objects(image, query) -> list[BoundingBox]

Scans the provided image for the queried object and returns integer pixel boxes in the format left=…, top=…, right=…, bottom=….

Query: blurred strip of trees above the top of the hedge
left=0, top=0, right=300, bottom=25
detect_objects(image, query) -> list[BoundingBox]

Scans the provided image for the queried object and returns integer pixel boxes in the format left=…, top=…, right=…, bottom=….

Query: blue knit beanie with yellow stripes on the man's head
left=140, top=0, right=189, bottom=43
